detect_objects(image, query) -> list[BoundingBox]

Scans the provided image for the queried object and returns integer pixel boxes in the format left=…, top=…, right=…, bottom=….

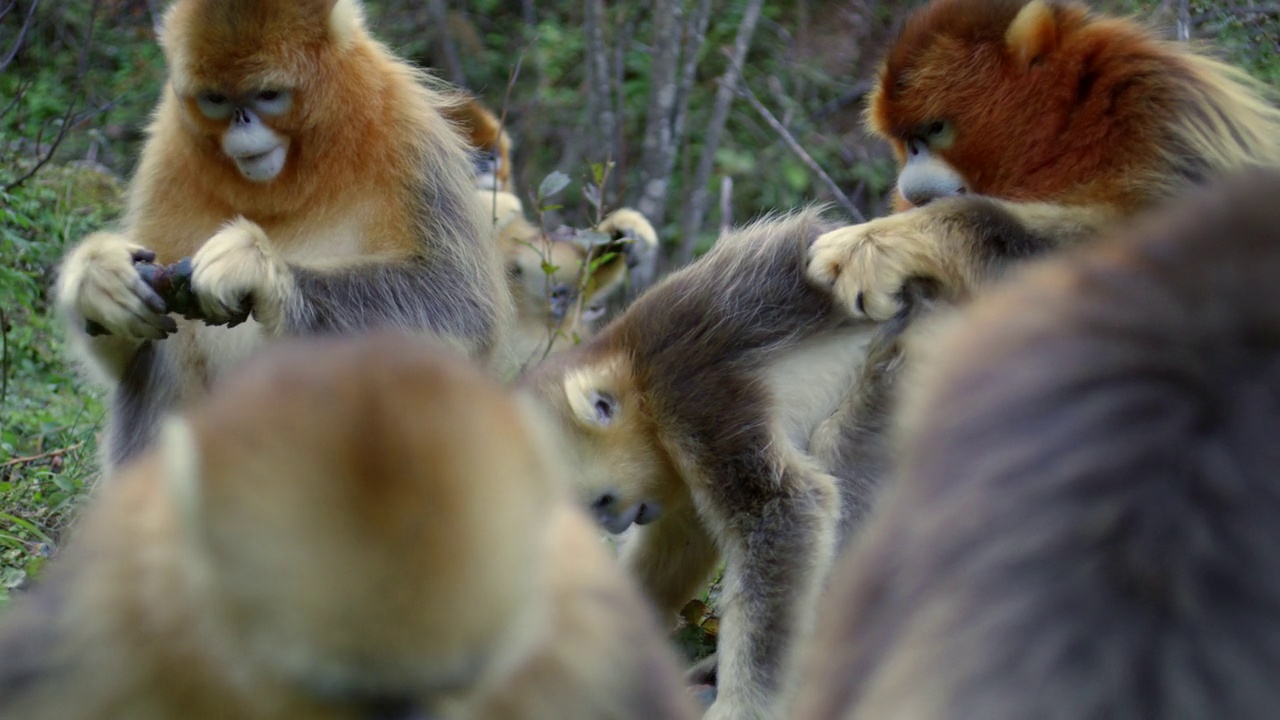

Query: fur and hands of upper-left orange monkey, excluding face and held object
left=58, top=0, right=512, bottom=464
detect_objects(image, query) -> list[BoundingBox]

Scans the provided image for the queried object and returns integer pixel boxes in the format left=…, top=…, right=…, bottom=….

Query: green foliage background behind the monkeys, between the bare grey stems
left=0, top=0, right=1280, bottom=603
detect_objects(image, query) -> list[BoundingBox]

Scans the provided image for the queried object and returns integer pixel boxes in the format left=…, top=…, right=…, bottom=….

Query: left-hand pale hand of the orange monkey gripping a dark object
left=56, top=232, right=178, bottom=340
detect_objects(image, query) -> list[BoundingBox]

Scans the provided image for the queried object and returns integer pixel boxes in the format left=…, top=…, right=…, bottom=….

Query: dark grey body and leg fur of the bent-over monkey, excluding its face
left=525, top=209, right=870, bottom=716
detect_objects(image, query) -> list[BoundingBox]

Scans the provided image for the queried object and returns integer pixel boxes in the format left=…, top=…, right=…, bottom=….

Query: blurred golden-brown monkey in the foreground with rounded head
left=0, top=334, right=694, bottom=720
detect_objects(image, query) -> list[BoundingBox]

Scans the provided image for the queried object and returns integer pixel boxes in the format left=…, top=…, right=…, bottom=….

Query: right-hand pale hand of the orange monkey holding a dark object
left=191, top=218, right=293, bottom=334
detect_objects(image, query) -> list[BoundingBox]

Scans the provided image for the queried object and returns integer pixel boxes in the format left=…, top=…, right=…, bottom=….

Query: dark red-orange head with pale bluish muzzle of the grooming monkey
left=868, top=0, right=1111, bottom=209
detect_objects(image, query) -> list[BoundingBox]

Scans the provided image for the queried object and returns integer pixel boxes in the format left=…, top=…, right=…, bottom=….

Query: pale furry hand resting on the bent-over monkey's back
left=808, top=210, right=955, bottom=322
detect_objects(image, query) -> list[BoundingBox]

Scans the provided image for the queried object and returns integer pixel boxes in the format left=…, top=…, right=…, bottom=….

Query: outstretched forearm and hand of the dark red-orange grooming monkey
left=809, top=196, right=1116, bottom=320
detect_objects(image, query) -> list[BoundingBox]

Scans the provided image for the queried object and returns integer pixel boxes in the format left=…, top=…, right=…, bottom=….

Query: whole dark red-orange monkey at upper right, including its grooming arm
left=812, top=0, right=1280, bottom=320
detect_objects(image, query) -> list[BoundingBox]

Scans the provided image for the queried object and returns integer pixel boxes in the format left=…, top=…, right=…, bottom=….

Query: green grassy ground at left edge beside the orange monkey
left=0, top=164, right=120, bottom=603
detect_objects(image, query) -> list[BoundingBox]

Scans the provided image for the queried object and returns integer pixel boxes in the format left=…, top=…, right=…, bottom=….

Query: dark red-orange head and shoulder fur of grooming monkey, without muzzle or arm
left=868, top=0, right=1280, bottom=214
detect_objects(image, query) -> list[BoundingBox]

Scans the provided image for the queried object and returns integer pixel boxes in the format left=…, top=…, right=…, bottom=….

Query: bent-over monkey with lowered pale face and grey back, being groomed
left=524, top=210, right=870, bottom=719
